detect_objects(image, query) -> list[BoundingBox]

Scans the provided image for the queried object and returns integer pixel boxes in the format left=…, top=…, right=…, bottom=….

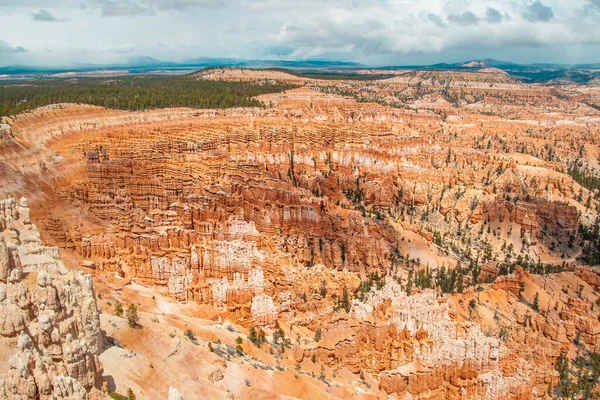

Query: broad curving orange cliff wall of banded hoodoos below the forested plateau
left=0, top=102, right=577, bottom=323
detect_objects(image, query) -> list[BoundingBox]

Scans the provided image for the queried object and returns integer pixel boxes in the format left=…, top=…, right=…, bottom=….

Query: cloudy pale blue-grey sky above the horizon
left=0, top=0, right=600, bottom=66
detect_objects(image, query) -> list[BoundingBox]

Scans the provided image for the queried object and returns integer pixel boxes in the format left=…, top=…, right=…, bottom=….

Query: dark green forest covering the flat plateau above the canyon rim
left=0, top=75, right=296, bottom=117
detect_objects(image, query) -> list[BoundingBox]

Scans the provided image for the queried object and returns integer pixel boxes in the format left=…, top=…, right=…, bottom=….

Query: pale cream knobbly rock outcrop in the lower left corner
left=0, top=198, right=102, bottom=400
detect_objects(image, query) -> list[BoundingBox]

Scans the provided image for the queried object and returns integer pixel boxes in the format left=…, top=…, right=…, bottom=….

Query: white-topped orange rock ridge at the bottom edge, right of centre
left=297, top=280, right=516, bottom=399
